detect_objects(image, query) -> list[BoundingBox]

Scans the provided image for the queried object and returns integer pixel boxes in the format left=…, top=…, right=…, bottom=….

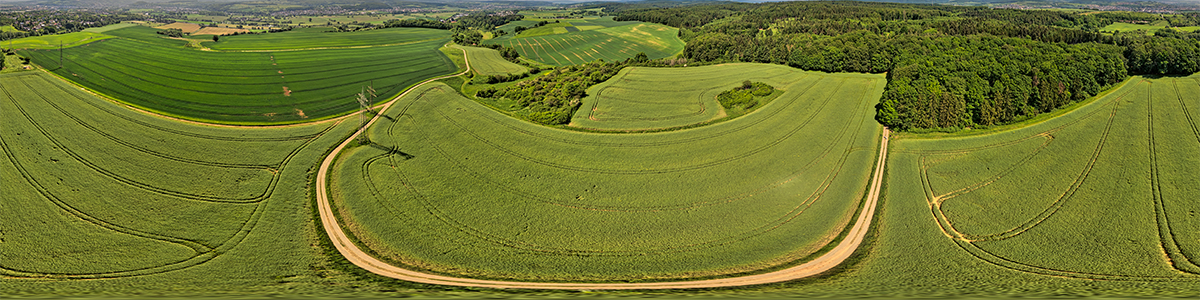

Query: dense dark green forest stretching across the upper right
left=599, top=1, right=1200, bottom=130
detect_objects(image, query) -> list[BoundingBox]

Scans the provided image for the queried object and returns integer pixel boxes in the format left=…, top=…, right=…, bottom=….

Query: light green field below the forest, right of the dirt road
left=888, top=77, right=1200, bottom=278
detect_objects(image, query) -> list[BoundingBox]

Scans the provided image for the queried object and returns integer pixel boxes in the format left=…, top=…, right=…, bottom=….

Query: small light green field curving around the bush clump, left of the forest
left=571, top=61, right=825, bottom=131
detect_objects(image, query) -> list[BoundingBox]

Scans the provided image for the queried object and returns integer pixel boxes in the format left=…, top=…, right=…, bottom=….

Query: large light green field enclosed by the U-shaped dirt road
left=329, top=66, right=883, bottom=282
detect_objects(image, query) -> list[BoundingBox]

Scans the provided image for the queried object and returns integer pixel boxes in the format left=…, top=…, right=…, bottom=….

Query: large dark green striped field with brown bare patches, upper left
left=23, top=26, right=456, bottom=124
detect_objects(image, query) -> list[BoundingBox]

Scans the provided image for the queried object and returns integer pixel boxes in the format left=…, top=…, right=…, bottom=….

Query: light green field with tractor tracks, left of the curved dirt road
left=0, top=72, right=350, bottom=279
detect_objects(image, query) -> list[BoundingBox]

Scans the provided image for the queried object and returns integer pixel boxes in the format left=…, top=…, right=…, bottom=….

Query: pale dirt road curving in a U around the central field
left=317, top=46, right=889, bottom=289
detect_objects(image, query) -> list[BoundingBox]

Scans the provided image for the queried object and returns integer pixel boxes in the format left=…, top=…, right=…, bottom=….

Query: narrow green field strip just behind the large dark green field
left=205, top=28, right=450, bottom=50
